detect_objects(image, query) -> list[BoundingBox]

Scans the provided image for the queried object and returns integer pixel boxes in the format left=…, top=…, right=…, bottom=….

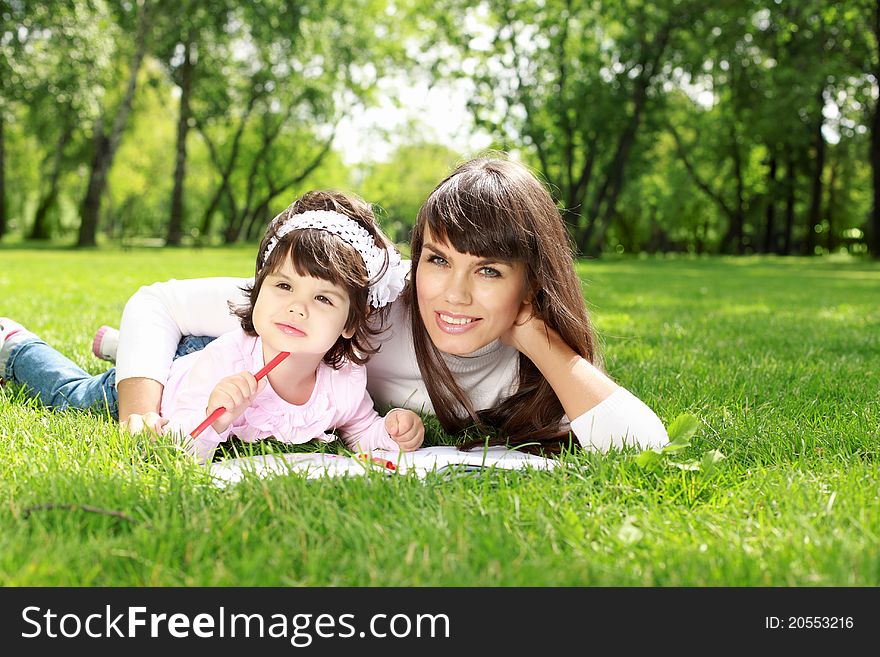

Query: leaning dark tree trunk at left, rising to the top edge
left=76, top=4, right=148, bottom=246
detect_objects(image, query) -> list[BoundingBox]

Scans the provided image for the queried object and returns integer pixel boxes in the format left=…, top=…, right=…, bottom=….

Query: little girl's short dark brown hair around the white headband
left=237, top=191, right=390, bottom=369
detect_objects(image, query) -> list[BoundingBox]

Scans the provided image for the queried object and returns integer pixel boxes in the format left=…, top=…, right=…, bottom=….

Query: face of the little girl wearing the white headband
left=253, top=258, right=354, bottom=357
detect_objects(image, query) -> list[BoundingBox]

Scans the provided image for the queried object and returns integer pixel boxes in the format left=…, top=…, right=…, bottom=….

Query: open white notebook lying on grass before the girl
left=211, top=446, right=558, bottom=488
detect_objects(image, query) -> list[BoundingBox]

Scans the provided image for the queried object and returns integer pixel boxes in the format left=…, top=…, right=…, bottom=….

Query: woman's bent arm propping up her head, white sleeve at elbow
left=505, top=306, right=669, bottom=450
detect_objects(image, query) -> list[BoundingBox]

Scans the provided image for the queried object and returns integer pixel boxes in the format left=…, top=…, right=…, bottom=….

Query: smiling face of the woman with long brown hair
left=416, top=228, right=527, bottom=356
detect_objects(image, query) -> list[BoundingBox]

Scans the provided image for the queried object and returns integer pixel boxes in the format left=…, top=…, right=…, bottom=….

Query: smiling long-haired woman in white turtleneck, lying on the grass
left=1, top=157, right=667, bottom=450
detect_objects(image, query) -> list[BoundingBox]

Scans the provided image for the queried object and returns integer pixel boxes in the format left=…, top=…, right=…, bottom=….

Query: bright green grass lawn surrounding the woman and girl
left=0, top=247, right=880, bottom=586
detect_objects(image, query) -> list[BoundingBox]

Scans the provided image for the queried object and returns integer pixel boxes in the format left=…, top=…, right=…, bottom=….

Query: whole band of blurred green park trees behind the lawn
left=0, top=0, right=880, bottom=256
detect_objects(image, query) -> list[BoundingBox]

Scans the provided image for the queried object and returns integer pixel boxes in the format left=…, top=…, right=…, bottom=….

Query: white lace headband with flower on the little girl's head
left=263, top=210, right=409, bottom=308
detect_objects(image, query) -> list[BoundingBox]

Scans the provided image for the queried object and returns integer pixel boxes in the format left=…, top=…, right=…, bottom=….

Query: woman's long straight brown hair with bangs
left=404, top=157, right=601, bottom=452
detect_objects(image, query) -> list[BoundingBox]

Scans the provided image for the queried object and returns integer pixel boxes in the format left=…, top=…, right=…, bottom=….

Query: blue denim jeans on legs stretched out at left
left=2, top=335, right=214, bottom=419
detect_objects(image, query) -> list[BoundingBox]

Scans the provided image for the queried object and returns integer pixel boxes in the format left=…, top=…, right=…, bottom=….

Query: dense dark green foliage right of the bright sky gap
left=422, top=0, right=878, bottom=254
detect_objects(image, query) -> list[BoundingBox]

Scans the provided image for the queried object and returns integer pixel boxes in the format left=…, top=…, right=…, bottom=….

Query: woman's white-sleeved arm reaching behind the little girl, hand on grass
left=116, top=278, right=250, bottom=421
